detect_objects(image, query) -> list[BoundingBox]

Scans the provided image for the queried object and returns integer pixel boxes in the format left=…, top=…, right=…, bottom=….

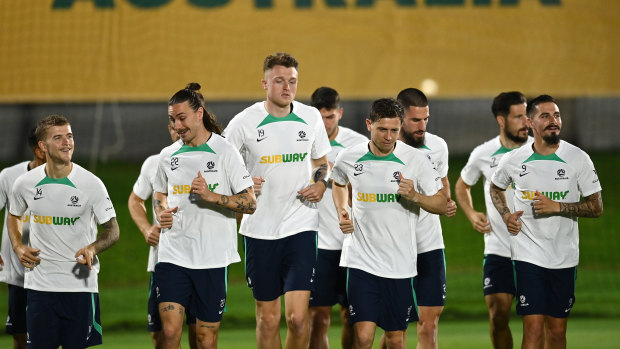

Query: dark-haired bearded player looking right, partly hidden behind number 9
left=454, top=91, right=532, bottom=348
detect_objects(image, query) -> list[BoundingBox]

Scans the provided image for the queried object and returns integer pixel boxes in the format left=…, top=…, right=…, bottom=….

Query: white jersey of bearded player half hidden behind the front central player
left=416, top=132, right=448, bottom=253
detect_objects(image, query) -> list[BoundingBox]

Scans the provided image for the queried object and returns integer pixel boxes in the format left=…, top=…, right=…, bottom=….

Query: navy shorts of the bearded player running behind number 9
left=482, top=254, right=516, bottom=296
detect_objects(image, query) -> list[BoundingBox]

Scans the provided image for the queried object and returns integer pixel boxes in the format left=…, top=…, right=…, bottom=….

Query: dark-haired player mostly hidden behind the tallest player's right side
left=310, top=87, right=368, bottom=349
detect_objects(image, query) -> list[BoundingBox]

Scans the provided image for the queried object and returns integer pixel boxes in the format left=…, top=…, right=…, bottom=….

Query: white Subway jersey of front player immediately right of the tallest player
left=331, top=141, right=441, bottom=279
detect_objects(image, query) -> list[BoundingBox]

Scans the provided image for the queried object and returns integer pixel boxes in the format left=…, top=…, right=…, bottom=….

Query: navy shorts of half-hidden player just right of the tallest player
left=310, top=249, right=349, bottom=308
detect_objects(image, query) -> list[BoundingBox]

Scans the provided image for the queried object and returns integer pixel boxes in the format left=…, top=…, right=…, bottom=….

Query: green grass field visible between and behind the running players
left=0, top=153, right=620, bottom=348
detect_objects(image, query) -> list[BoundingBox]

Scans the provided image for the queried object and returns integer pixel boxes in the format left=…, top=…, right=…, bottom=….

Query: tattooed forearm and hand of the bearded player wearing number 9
left=534, top=191, right=603, bottom=218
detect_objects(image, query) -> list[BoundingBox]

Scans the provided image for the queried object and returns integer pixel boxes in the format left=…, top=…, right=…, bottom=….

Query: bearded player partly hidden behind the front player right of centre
left=397, top=88, right=456, bottom=348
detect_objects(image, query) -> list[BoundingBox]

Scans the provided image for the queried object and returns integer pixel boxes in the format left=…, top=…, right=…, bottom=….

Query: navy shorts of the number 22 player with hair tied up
left=154, top=263, right=228, bottom=322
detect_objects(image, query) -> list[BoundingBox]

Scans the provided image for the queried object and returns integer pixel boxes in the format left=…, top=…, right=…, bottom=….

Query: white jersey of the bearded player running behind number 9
left=461, top=136, right=533, bottom=258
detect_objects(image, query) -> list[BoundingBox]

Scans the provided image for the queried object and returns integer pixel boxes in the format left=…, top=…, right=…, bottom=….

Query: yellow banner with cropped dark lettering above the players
left=0, top=0, right=620, bottom=103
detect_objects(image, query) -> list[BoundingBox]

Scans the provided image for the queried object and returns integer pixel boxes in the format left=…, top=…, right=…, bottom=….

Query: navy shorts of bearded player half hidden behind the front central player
left=413, top=249, right=446, bottom=307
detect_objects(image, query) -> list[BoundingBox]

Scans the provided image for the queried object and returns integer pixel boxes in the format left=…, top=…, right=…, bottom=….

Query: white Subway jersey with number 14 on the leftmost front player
left=10, top=163, right=116, bottom=292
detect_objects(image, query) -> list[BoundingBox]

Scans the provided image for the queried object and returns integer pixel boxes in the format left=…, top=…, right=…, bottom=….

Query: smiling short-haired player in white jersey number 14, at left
left=7, top=115, right=119, bottom=348
